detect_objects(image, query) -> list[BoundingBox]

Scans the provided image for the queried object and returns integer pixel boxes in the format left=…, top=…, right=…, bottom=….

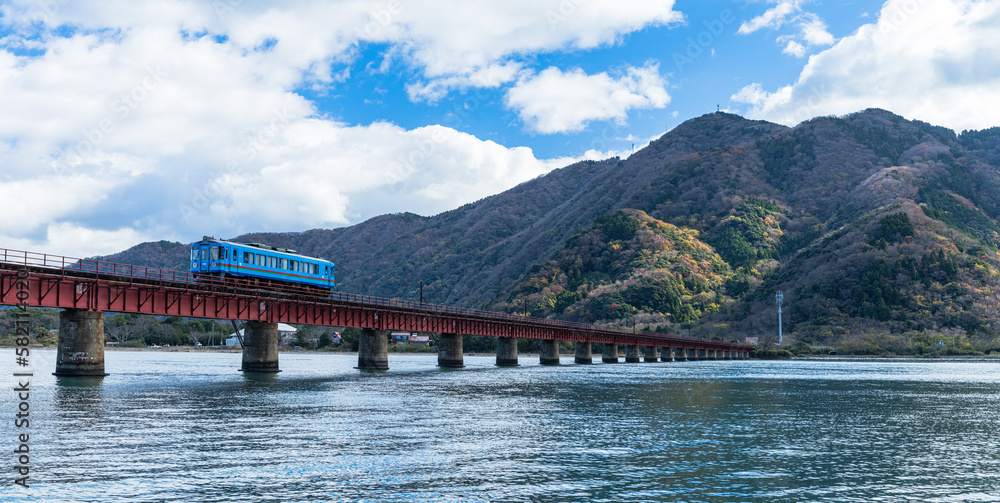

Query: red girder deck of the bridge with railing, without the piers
left=0, top=249, right=753, bottom=351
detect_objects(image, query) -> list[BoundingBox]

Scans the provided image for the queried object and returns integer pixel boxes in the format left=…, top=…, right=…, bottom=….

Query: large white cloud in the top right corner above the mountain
left=731, top=0, right=1000, bottom=130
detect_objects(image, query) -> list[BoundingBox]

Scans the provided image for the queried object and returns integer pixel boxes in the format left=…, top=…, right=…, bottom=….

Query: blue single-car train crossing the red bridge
left=191, top=236, right=334, bottom=289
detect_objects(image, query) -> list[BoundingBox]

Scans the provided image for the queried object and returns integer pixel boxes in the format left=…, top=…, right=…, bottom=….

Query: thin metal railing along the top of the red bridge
left=0, top=248, right=752, bottom=343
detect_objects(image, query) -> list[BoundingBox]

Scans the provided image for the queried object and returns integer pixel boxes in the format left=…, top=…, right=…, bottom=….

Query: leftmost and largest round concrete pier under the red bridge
left=53, top=309, right=108, bottom=377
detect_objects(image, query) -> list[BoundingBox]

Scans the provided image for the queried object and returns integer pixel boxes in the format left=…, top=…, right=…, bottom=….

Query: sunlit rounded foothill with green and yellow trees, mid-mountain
left=504, top=210, right=731, bottom=329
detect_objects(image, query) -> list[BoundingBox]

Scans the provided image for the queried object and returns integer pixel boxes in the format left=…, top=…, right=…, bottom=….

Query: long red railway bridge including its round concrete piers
left=0, top=248, right=753, bottom=376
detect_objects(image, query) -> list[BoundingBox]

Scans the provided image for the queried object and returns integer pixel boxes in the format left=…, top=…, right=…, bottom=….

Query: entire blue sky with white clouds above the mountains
left=0, top=0, right=1000, bottom=256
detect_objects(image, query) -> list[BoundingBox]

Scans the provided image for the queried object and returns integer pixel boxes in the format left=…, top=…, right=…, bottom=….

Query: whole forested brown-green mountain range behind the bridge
left=99, top=109, right=1000, bottom=352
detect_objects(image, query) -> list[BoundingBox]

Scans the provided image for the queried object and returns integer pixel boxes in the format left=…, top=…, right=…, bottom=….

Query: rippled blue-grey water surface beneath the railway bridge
left=0, top=349, right=1000, bottom=502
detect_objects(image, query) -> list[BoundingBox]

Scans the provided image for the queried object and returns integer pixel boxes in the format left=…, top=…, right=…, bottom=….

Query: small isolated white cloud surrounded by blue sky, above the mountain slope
left=505, top=64, right=670, bottom=134
